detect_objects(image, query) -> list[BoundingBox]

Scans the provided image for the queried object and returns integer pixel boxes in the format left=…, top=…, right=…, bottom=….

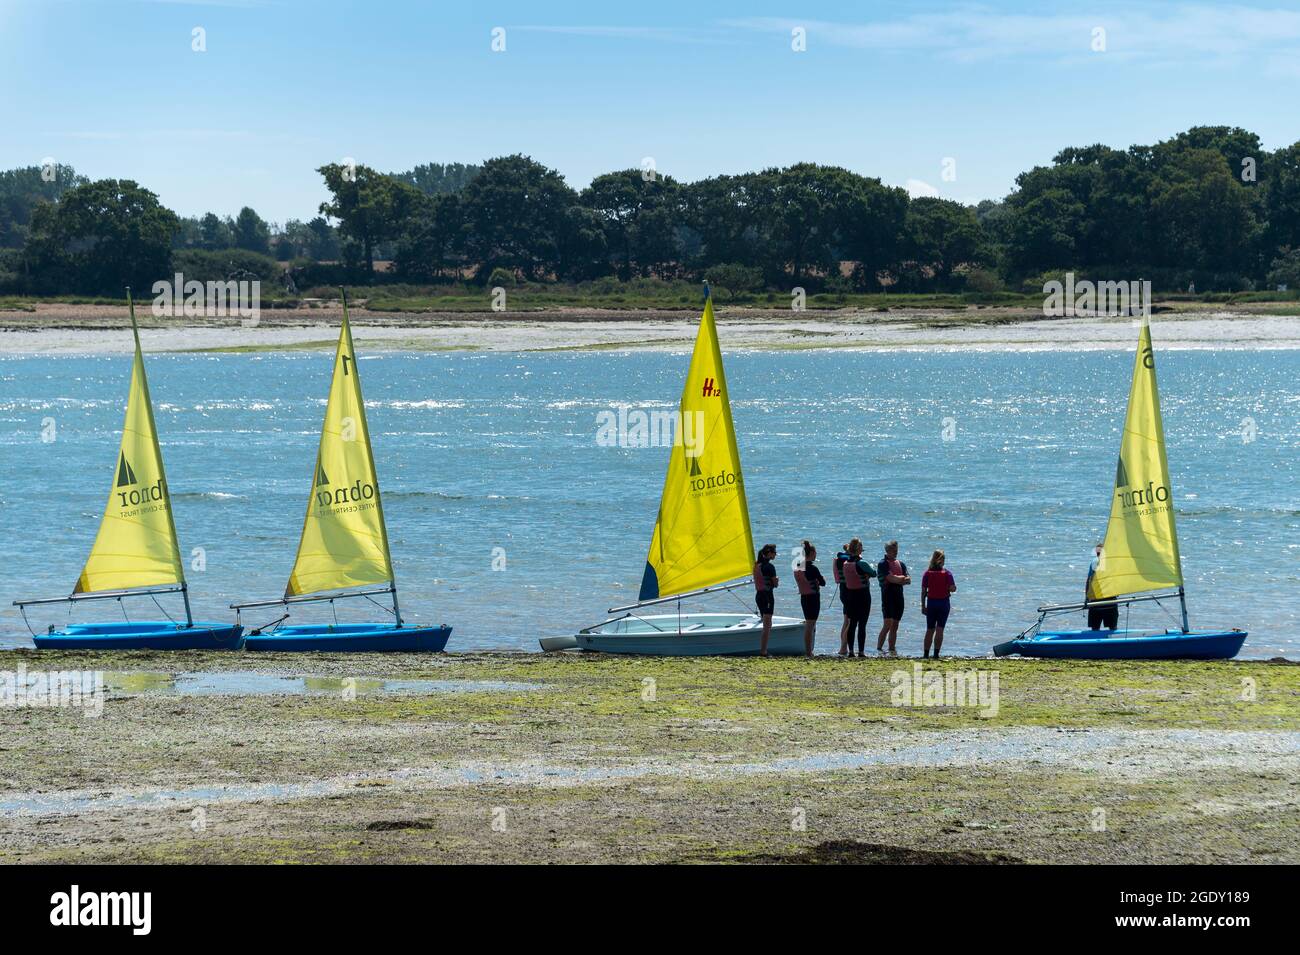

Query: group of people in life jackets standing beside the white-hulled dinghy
left=754, top=538, right=957, bottom=657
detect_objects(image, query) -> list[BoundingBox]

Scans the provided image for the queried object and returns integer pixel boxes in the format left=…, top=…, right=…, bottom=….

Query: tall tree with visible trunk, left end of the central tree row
left=317, top=162, right=426, bottom=274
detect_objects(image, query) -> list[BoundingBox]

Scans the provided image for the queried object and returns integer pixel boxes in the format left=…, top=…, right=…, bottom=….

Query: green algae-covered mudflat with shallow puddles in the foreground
left=0, top=651, right=1300, bottom=863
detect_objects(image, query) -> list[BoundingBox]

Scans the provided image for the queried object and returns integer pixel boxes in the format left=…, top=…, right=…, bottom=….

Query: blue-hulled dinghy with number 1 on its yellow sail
left=230, top=292, right=451, bottom=652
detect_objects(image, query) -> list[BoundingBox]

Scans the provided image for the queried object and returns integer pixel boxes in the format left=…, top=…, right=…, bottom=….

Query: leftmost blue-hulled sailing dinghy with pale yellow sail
left=14, top=288, right=241, bottom=650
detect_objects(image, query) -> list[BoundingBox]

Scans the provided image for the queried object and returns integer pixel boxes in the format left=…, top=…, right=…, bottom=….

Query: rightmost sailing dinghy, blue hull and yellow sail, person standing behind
left=993, top=316, right=1247, bottom=660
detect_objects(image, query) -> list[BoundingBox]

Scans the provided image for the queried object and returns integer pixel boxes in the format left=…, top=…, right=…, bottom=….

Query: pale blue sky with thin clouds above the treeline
left=0, top=0, right=1300, bottom=222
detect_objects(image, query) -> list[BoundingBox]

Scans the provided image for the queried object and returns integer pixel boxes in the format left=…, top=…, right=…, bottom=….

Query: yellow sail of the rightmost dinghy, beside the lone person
left=1088, top=318, right=1183, bottom=600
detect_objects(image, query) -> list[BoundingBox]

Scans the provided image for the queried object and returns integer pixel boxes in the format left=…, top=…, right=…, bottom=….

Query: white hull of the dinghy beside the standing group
left=573, top=613, right=803, bottom=656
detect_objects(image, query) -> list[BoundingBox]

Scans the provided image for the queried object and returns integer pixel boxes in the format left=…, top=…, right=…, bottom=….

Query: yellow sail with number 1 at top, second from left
left=285, top=300, right=393, bottom=596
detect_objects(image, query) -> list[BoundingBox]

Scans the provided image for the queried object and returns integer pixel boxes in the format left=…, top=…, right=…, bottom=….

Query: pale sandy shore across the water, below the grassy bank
left=0, top=304, right=1300, bottom=355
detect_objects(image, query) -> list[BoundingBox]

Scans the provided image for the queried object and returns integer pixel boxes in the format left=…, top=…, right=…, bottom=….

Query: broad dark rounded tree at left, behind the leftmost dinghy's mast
left=25, top=179, right=181, bottom=295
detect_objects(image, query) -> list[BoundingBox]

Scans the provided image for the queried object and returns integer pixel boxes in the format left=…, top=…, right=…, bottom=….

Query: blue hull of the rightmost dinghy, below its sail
left=993, top=630, right=1247, bottom=660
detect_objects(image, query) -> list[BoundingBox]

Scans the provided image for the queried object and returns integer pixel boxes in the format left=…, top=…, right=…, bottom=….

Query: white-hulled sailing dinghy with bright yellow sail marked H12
left=541, top=292, right=803, bottom=656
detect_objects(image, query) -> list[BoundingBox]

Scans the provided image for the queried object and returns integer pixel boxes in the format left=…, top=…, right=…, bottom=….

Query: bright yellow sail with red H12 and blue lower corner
left=640, top=299, right=754, bottom=600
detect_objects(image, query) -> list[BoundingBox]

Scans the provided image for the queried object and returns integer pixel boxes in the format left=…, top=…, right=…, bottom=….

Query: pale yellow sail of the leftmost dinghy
left=73, top=298, right=185, bottom=594
